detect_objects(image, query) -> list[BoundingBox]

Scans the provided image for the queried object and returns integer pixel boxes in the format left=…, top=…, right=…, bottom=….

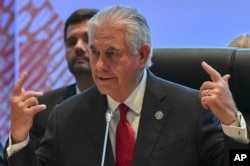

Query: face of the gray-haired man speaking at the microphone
left=89, top=26, right=146, bottom=102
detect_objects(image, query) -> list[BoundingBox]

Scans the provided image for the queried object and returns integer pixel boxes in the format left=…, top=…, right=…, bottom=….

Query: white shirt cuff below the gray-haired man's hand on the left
left=6, top=134, right=29, bottom=157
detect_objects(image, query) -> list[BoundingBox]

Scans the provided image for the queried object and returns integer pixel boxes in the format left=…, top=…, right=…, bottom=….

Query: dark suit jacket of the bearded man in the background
left=30, top=84, right=76, bottom=148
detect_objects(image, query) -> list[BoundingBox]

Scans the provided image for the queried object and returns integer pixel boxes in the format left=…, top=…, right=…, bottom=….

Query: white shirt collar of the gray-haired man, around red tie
left=107, top=69, right=147, bottom=114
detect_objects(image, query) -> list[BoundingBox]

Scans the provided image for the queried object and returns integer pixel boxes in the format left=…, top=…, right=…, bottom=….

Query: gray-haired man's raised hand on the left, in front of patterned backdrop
left=10, top=72, right=46, bottom=144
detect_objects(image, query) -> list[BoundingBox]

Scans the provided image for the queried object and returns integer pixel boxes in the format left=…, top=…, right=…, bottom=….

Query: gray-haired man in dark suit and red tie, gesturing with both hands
left=2, top=6, right=249, bottom=166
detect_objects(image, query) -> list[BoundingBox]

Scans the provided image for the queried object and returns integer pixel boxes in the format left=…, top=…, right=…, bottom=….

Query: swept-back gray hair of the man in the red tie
left=88, top=5, right=153, bottom=68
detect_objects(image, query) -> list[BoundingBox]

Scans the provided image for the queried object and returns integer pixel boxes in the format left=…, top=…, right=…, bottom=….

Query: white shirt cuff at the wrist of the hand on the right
left=221, top=111, right=249, bottom=144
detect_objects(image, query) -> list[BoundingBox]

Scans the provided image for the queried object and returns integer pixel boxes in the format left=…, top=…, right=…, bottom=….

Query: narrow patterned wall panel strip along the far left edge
left=0, top=0, right=15, bottom=143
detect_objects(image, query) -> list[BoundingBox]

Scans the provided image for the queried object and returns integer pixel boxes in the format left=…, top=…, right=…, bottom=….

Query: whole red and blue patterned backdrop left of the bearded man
left=0, top=0, right=73, bottom=143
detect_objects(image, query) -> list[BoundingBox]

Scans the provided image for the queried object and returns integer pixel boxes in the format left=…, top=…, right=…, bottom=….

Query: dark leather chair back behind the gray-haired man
left=150, top=48, right=250, bottom=123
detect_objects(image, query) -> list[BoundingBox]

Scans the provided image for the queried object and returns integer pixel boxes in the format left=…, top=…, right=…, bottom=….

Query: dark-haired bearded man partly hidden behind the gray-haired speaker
left=30, top=9, right=97, bottom=148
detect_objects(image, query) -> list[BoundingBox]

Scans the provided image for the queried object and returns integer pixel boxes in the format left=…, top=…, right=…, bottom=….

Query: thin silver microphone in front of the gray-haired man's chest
left=101, top=110, right=113, bottom=166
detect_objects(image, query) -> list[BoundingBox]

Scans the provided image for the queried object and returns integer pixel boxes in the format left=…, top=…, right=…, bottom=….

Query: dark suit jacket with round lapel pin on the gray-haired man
left=4, top=72, right=250, bottom=166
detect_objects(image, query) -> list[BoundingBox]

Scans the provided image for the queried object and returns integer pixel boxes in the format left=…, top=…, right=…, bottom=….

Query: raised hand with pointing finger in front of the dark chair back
left=200, top=62, right=238, bottom=124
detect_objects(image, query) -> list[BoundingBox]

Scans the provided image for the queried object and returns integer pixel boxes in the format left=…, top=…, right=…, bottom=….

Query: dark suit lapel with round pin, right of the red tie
left=133, top=72, right=168, bottom=165
